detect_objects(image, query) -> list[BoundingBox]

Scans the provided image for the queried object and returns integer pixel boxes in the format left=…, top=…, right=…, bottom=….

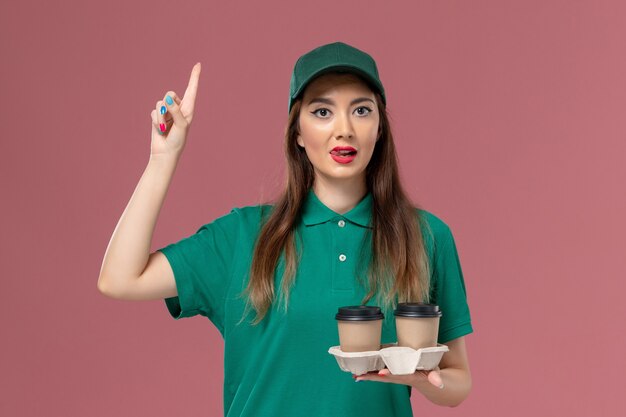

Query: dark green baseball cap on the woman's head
left=289, top=42, right=387, bottom=111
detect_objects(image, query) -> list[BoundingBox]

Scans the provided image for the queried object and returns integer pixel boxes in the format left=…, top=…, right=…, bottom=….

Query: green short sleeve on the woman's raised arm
left=158, top=210, right=239, bottom=332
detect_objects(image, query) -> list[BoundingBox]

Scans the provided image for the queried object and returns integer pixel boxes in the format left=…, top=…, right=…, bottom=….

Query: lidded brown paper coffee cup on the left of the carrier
left=335, top=306, right=385, bottom=352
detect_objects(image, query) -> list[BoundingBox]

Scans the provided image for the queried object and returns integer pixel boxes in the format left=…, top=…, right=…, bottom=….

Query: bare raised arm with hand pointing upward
left=98, top=63, right=200, bottom=300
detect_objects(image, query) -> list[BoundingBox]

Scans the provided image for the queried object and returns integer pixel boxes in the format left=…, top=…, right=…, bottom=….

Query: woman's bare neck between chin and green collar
left=313, top=176, right=367, bottom=214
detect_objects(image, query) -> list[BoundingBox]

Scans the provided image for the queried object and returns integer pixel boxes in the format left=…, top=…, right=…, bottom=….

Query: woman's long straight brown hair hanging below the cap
left=244, top=79, right=430, bottom=324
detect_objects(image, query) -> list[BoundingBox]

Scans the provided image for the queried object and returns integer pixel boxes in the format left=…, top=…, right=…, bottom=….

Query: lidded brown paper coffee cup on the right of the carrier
left=393, top=303, right=441, bottom=350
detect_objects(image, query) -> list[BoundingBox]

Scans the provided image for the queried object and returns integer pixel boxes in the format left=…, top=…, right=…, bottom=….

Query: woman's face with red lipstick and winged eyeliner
left=297, top=74, right=380, bottom=187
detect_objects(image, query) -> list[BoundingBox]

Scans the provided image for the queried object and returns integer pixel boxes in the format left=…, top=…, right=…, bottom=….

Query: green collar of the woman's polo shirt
left=302, top=188, right=372, bottom=227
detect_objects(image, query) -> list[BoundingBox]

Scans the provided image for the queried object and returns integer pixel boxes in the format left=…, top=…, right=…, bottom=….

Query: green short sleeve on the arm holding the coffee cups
left=431, top=226, right=473, bottom=344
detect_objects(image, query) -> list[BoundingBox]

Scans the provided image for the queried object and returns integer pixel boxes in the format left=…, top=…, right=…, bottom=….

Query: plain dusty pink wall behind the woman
left=0, top=0, right=626, bottom=417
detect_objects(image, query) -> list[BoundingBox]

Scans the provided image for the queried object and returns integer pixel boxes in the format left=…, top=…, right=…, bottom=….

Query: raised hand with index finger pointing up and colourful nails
left=150, top=62, right=200, bottom=157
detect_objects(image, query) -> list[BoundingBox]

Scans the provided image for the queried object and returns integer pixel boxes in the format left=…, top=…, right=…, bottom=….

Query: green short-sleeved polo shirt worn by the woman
left=160, top=190, right=472, bottom=417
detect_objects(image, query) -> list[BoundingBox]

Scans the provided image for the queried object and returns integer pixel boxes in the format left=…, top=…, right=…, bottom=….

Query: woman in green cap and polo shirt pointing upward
left=98, top=42, right=472, bottom=417
